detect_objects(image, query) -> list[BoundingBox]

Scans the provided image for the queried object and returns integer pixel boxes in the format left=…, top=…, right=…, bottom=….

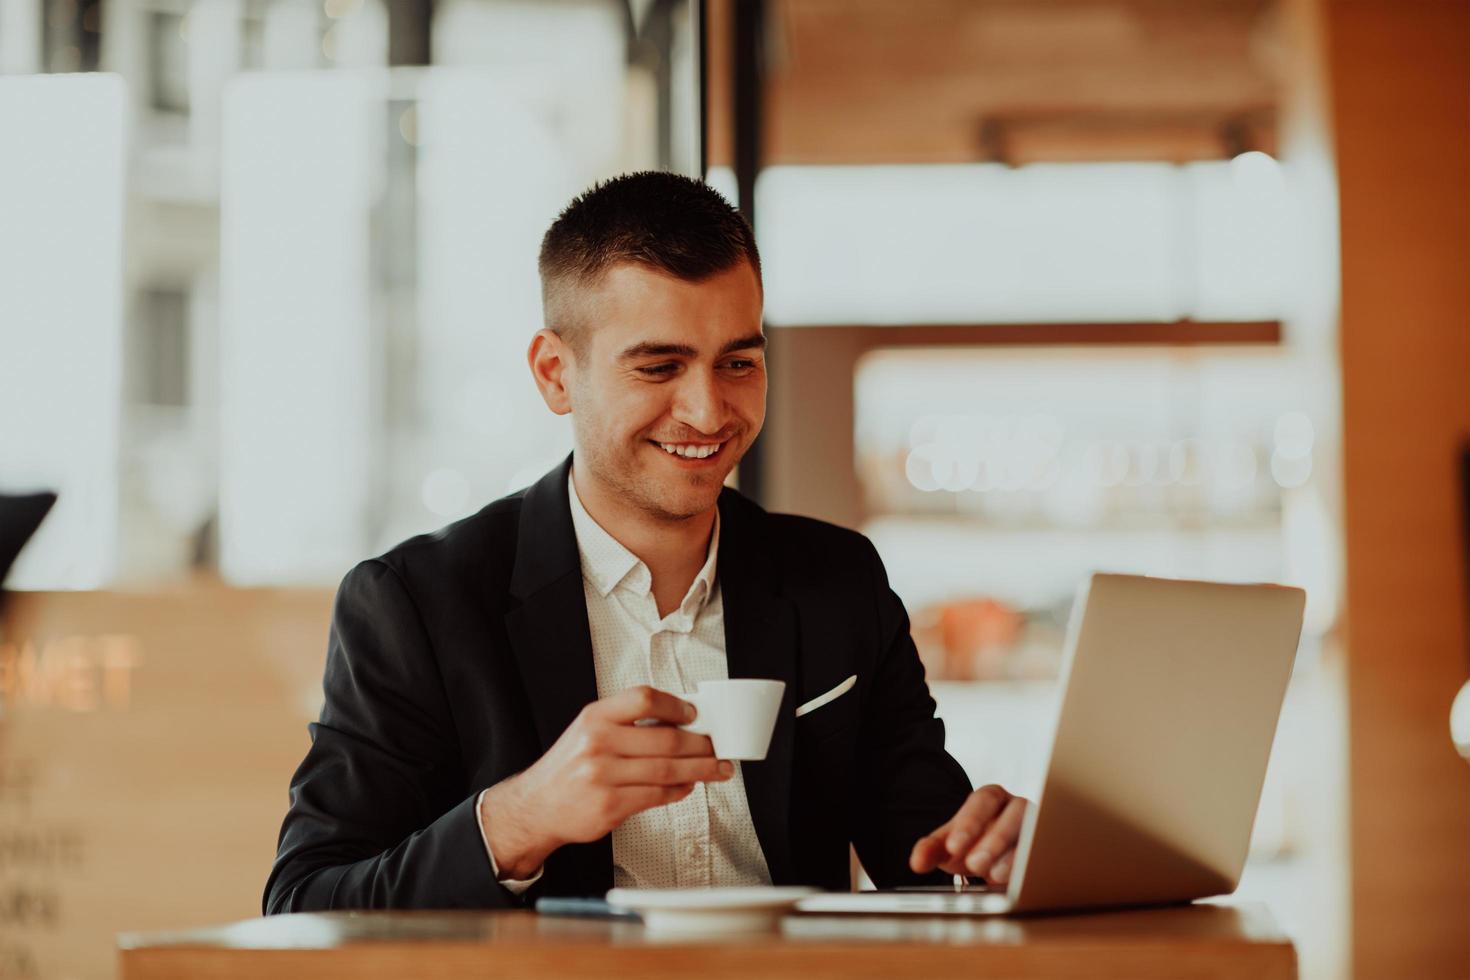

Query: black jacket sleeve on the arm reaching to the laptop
left=853, top=544, right=970, bottom=887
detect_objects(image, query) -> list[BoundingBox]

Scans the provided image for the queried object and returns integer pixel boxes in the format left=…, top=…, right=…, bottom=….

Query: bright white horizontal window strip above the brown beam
left=756, top=153, right=1314, bottom=326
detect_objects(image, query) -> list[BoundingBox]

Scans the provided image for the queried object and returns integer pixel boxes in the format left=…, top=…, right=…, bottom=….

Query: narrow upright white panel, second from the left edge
left=219, top=72, right=385, bottom=583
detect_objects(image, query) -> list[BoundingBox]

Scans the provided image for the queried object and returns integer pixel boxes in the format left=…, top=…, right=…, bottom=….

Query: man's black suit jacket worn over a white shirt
left=265, top=458, right=970, bottom=914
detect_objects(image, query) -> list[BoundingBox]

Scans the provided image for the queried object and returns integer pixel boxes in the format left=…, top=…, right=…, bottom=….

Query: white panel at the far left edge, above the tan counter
left=0, top=73, right=126, bottom=589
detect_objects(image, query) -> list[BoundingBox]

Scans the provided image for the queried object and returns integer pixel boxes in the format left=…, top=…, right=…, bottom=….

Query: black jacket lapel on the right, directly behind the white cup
left=719, top=491, right=797, bottom=884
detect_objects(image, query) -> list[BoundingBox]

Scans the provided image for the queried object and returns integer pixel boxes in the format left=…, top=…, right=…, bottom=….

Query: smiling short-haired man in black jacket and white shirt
left=265, top=173, right=1026, bottom=914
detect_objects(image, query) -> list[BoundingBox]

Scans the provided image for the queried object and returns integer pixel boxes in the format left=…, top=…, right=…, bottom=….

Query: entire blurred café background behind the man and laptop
left=0, top=0, right=1470, bottom=979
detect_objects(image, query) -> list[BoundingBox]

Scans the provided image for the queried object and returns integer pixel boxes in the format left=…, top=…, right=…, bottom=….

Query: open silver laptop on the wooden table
left=797, top=573, right=1305, bottom=915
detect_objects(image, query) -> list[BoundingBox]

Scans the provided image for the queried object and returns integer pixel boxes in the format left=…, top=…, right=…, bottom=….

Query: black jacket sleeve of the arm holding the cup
left=263, top=561, right=519, bottom=915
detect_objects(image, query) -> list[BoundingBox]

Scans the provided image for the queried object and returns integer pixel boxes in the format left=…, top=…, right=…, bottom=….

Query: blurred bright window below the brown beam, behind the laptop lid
left=854, top=347, right=1338, bottom=679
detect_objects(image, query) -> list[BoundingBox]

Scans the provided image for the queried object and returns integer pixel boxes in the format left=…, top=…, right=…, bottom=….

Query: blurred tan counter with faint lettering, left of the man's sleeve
left=0, top=580, right=332, bottom=977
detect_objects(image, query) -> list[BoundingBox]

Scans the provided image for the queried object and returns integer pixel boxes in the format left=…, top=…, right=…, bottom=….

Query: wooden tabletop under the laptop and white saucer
left=118, top=905, right=1297, bottom=980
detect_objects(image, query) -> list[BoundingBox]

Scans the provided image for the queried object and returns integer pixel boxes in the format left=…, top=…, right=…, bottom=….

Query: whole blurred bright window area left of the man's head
left=0, top=0, right=700, bottom=588
